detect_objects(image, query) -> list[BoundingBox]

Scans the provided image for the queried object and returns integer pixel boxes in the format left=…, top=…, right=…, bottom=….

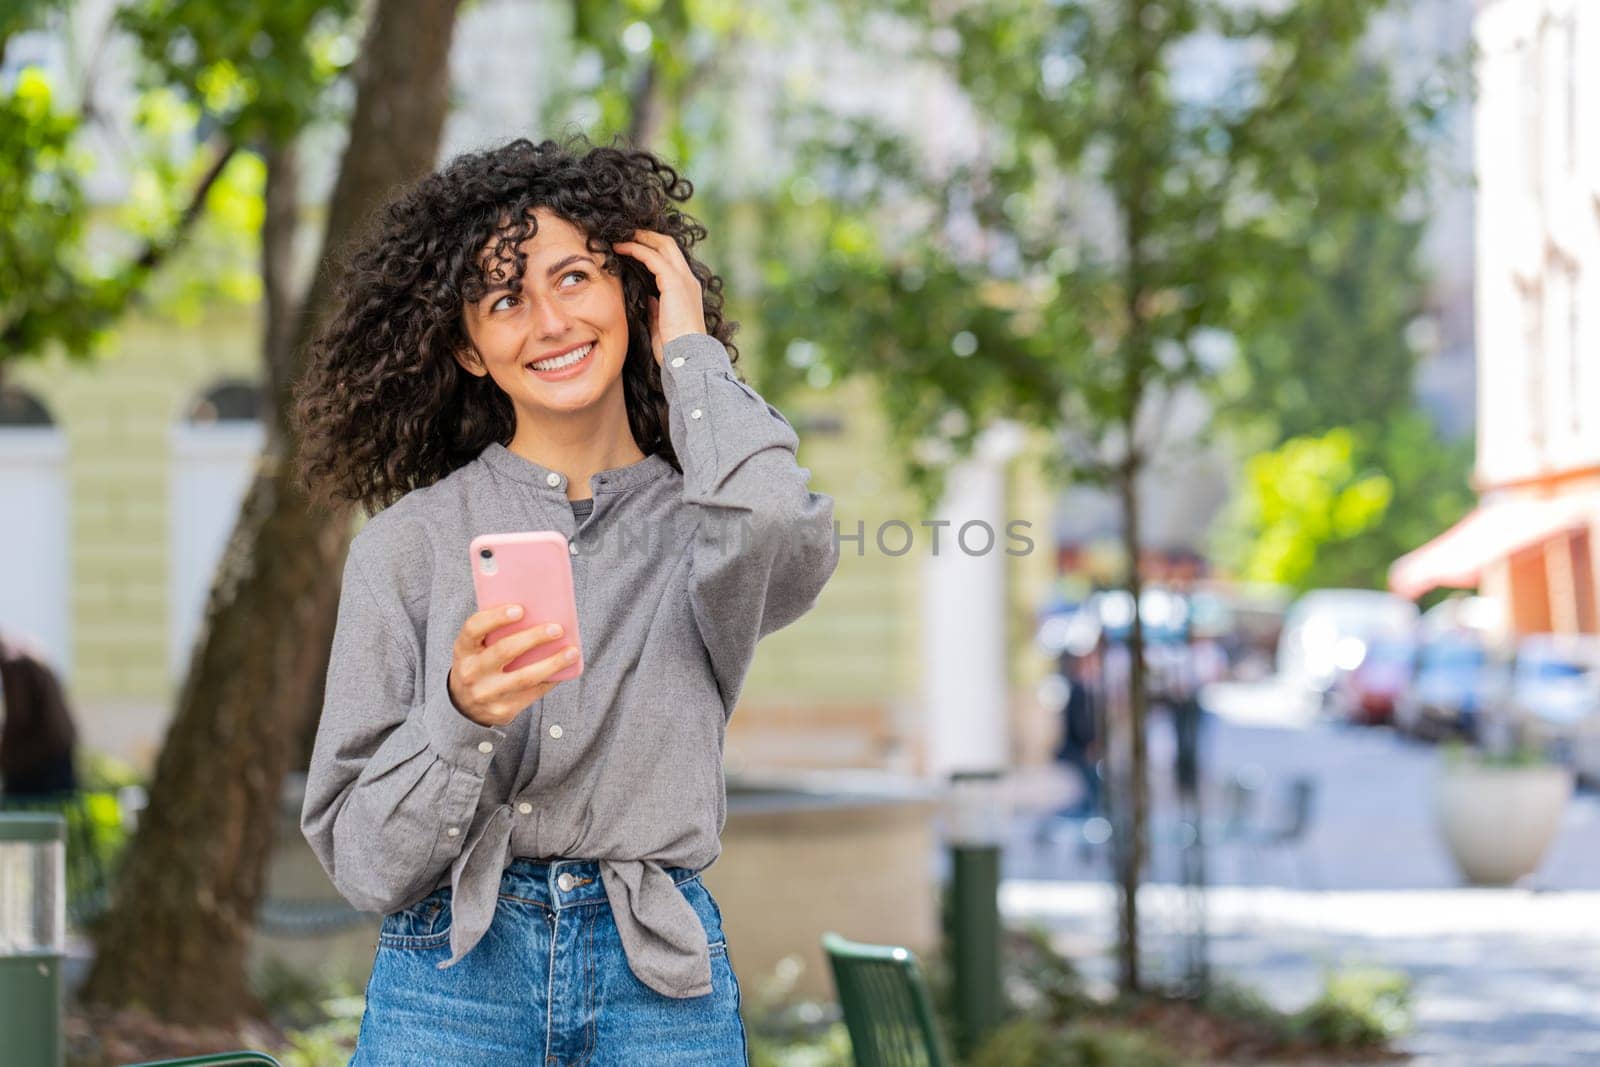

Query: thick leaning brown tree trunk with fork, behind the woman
left=83, top=0, right=458, bottom=1024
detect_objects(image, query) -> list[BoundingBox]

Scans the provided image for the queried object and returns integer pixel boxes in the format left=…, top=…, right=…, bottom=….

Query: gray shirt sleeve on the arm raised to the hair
left=661, top=333, right=838, bottom=715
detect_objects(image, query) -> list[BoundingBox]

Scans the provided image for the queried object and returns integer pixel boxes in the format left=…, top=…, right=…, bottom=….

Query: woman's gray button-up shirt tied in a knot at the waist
left=301, top=333, right=838, bottom=997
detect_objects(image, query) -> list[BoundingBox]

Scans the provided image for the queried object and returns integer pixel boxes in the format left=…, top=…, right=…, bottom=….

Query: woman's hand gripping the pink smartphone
left=446, top=605, right=578, bottom=726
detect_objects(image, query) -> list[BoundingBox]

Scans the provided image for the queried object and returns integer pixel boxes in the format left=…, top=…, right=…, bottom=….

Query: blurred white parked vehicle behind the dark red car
left=1277, top=589, right=1419, bottom=709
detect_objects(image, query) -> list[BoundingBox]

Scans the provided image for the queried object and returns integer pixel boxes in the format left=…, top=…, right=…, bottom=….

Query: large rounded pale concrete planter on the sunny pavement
left=1434, top=760, right=1573, bottom=886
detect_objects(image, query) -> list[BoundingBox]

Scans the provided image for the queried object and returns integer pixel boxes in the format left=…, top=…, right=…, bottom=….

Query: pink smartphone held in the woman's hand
left=470, top=530, right=584, bottom=681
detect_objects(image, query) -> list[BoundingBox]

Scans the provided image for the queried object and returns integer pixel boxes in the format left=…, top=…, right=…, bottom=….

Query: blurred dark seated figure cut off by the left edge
left=0, top=632, right=78, bottom=797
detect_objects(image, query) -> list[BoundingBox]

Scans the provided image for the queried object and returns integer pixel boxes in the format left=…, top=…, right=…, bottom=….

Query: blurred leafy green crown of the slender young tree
left=736, top=0, right=1442, bottom=518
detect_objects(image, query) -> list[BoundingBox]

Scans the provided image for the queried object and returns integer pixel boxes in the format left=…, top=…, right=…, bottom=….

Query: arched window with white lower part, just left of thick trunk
left=166, top=378, right=266, bottom=681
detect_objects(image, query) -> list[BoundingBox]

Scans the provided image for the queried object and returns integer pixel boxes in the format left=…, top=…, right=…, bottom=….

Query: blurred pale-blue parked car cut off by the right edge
left=1483, top=633, right=1600, bottom=781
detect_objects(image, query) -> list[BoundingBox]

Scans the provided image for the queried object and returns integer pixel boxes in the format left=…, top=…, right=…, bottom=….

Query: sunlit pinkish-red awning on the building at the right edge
left=1389, top=494, right=1600, bottom=600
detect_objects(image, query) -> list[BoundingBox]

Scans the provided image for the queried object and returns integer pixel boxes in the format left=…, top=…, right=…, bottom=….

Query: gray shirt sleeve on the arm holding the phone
left=301, top=537, right=506, bottom=913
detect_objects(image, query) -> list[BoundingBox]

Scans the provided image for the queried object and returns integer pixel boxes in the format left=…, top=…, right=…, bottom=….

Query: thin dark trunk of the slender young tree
left=1117, top=461, right=1149, bottom=993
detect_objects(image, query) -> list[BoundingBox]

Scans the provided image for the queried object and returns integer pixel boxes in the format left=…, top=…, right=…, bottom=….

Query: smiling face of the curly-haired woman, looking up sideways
left=456, top=208, right=629, bottom=432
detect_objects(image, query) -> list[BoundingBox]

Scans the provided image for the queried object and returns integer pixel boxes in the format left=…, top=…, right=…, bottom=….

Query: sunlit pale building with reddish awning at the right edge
left=1390, top=0, right=1600, bottom=633
